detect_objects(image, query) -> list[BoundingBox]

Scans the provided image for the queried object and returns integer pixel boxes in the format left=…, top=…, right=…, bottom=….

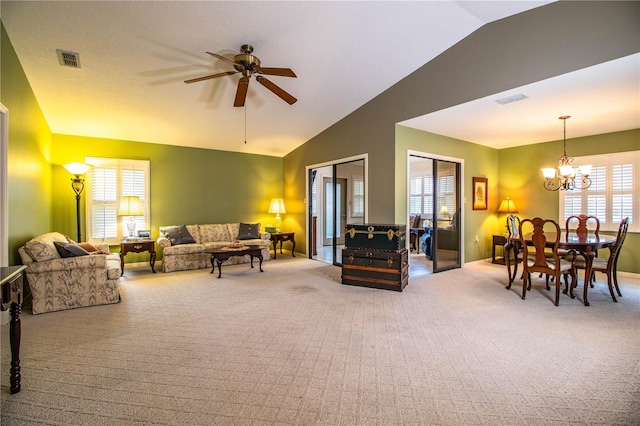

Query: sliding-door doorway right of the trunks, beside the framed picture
left=407, top=151, right=464, bottom=274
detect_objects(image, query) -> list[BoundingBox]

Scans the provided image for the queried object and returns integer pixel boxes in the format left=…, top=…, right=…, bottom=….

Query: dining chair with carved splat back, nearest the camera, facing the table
left=518, top=217, right=576, bottom=306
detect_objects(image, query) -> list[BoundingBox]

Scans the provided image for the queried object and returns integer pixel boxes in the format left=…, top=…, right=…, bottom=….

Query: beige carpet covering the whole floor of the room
left=1, top=256, right=640, bottom=425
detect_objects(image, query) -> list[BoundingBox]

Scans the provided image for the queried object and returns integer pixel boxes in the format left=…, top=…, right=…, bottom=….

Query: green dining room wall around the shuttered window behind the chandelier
left=498, top=129, right=640, bottom=274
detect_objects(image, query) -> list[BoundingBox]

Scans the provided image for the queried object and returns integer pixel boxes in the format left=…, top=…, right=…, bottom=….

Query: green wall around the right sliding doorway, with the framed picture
left=395, top=125, right=502, bottom=262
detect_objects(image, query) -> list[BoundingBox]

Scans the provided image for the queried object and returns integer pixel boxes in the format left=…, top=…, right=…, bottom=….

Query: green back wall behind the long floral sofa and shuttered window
left=51, top=135, right=282, bottom=261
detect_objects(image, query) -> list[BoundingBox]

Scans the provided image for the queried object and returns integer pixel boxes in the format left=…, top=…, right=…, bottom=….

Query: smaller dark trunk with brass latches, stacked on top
left=344, top=224, right=407, bottom=252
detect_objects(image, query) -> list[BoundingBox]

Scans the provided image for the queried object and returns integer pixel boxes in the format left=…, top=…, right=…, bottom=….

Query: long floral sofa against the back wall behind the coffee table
left=157, top=223, right=271, bottom=272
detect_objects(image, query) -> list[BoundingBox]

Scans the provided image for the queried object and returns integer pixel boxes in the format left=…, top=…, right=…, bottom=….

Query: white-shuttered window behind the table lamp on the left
left=85, top=157, right=151, bottom=244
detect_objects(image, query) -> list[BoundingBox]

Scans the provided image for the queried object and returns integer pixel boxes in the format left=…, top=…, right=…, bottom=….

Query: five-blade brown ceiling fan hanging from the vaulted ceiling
left=185, top=44, right=297, bottom=107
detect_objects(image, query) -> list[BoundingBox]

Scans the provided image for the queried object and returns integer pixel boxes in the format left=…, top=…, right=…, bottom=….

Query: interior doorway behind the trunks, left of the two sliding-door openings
left=307, top=154, right=368, bottom=266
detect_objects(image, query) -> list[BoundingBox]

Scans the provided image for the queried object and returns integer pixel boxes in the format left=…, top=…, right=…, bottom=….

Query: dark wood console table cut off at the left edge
left=0, top=266, right=27, bottom=393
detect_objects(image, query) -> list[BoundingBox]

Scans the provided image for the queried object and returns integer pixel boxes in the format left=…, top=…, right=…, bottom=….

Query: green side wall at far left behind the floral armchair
left=0, top=25, right=52, bottom=265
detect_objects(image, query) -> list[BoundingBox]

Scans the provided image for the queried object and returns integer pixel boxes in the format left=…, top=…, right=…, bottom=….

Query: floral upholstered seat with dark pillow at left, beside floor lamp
left=18, top=232, right=121, bottom=314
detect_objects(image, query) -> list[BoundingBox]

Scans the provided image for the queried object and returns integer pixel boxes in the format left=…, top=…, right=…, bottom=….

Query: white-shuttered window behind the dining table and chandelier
left=559, top=151, right=640, bottom=232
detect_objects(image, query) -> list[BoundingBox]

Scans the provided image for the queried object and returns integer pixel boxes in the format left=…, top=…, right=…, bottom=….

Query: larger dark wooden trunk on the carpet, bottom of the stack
left=342, top=249, right=409, bottom=291
